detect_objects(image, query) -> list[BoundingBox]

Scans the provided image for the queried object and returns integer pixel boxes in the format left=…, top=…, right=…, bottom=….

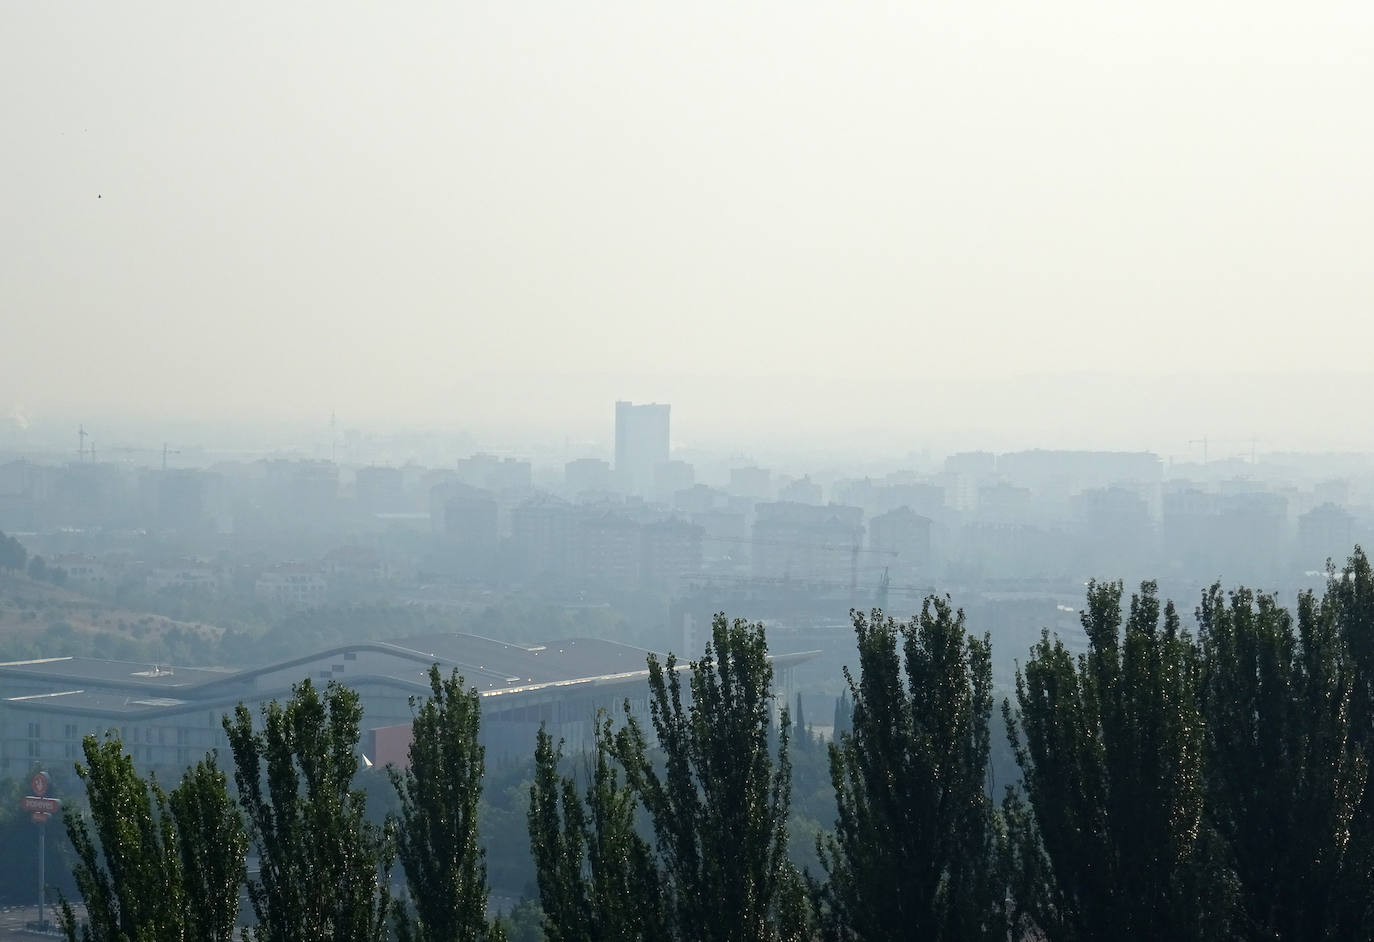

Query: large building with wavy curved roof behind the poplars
left=0, top=634, right=813, bottom=781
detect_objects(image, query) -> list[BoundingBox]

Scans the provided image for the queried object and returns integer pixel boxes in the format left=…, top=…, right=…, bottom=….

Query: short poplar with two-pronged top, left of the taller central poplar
left=529, top=715, right=669, bottom=942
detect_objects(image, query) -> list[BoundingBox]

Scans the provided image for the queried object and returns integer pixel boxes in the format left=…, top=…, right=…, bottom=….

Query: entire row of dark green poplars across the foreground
left=63, top=549, right=1374, bottom=942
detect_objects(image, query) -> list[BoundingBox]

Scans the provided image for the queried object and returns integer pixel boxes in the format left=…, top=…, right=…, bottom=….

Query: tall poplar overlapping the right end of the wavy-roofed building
left=614, top=615, right=807, bottom=942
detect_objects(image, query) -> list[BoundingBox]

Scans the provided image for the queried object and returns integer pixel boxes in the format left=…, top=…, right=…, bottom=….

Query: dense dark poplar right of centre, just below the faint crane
left=812, top=596, right=1009, bottom=941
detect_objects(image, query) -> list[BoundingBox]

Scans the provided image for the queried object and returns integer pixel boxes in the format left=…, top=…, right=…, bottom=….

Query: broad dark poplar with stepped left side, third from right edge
left=1003, top=582, right=1231, bottom=939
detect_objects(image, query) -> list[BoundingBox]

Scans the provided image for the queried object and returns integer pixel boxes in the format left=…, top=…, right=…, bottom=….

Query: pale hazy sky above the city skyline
left=0, top=0, right=1374, bottom=448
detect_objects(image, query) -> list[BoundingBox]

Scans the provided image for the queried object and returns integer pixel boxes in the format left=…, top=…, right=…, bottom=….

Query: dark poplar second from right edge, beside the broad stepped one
left=1197, top=585, right=1367, bottom=942
